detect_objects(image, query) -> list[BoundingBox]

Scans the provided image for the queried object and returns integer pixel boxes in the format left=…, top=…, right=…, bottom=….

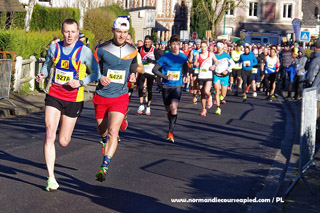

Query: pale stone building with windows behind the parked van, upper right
left=218, top=0, right=303, bottom=37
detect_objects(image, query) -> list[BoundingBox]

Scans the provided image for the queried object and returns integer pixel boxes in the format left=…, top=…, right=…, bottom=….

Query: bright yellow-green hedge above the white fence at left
left=0, top=30, right=94, bottom=59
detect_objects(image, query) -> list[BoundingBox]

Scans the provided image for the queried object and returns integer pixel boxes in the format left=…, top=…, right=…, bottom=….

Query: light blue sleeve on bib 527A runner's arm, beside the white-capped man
left=80, top=46, right=100, bottom=85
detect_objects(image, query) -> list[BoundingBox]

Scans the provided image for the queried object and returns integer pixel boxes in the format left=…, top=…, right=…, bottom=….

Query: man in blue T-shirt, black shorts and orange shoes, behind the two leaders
left=152, top=35, right=188, bottom=143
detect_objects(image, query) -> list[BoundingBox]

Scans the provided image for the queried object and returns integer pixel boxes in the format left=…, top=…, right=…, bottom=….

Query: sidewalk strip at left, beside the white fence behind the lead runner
left=0, top=83, right=96, bottom=118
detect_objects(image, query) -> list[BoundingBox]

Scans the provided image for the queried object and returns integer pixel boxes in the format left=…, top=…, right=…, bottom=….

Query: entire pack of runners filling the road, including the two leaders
left=37, top=17, right=308, bottom=191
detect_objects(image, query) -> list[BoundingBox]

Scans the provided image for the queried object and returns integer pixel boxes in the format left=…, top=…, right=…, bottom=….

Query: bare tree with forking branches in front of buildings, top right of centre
left=197, top=0, right=246, bottom=38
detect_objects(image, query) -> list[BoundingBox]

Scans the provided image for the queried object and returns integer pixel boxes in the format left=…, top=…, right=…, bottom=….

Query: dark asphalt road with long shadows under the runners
left=0, top=91, right=286, bottom=212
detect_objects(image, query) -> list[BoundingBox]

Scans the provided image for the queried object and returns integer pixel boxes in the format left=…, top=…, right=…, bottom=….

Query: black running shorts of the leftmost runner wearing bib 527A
left=45, top=95, right=84, bottom=118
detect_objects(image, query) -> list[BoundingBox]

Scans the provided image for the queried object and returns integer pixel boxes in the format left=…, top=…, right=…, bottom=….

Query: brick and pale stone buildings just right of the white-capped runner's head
left=118, top=0, right=192, bottom=42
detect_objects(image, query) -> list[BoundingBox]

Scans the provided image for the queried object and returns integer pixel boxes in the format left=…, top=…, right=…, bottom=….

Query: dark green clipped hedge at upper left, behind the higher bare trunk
left=30, top=5, right=80, bottom=31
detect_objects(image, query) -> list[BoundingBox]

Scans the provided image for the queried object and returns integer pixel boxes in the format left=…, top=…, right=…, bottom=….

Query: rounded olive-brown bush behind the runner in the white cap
left=83, top=4, right=134, bottom=46
